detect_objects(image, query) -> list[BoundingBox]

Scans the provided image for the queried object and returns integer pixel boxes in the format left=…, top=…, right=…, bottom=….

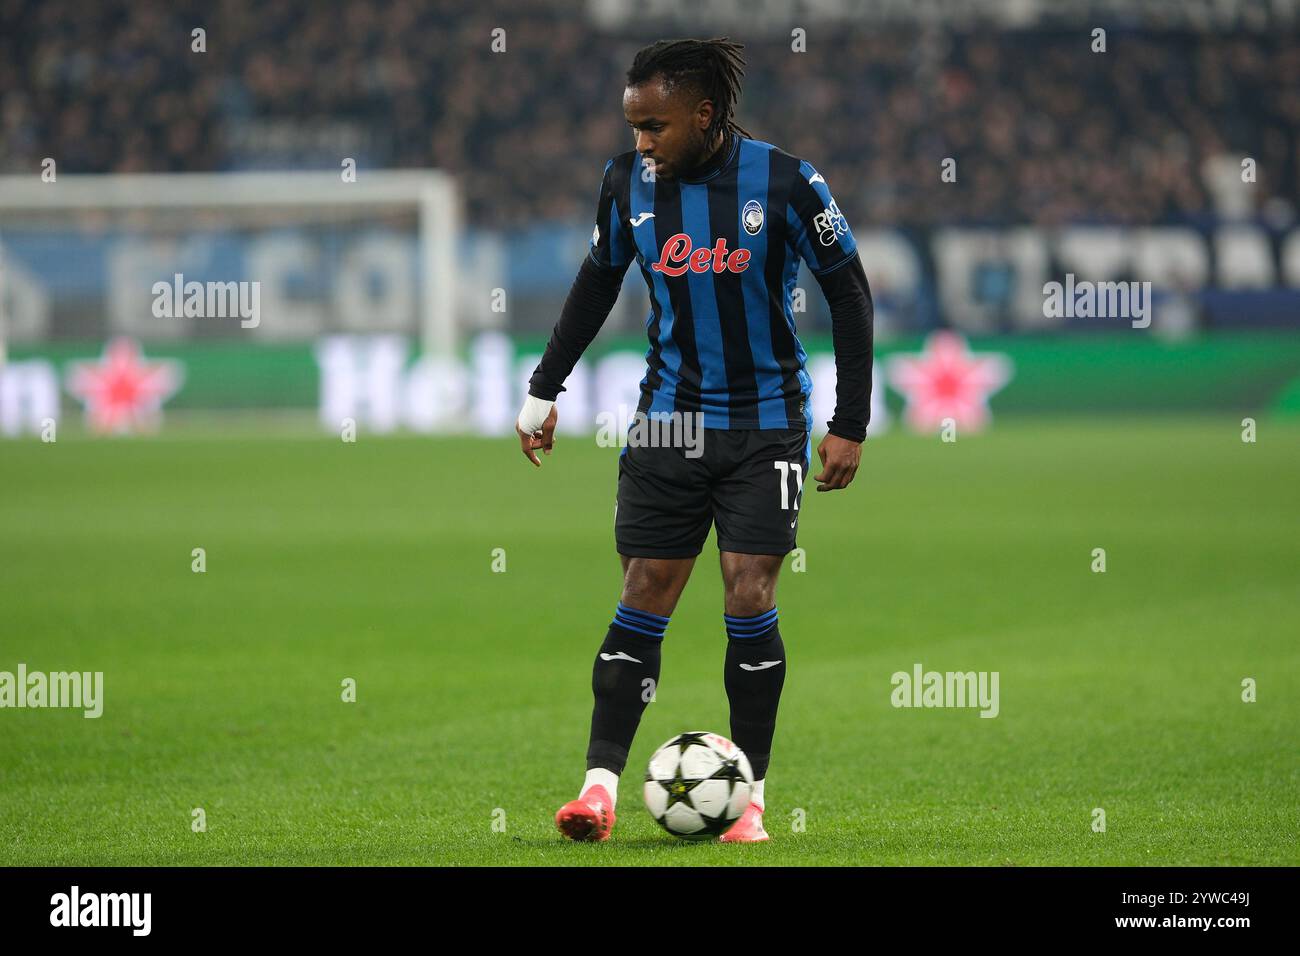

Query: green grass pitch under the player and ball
left=0, top=416, right=1300, bottom=865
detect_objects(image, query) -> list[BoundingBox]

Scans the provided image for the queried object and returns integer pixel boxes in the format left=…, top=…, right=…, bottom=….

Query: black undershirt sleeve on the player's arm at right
left=814, top=252, right=875, bottom=442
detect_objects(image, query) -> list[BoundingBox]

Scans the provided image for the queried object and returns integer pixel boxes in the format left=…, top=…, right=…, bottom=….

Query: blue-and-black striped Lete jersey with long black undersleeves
left=530, top=134, right=870, bottom=441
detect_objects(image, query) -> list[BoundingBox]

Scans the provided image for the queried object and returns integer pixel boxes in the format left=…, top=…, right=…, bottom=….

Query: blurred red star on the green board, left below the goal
left=68, top=338, right=183, bottom=433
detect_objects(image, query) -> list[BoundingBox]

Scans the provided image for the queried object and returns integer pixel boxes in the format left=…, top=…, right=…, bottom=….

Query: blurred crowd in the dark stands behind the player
left=0, top=0, right=1300, bottom=229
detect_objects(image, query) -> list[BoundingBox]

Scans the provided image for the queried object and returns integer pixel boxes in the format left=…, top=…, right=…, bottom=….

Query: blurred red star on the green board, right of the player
left=889, top=332, right=1011, bottom=432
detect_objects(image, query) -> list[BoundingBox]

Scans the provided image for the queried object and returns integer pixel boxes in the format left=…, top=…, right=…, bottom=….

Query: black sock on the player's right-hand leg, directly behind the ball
left=723, top=607, right=785, bottom=780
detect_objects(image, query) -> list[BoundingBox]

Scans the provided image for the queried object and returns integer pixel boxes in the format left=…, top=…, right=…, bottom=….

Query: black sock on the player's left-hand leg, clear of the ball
left=586, top=601, right=668, bottom=774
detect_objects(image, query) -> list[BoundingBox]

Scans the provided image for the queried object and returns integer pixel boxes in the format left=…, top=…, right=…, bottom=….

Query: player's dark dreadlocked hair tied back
left=628, top=36, right=754, bottom=142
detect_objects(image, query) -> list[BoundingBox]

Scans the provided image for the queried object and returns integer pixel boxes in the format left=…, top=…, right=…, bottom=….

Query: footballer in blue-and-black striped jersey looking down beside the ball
left=516, top=38, right=872, bottom=843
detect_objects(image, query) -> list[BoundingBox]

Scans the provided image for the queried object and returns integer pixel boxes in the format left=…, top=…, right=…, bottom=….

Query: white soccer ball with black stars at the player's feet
left=645, top=731, right=754, bottom=840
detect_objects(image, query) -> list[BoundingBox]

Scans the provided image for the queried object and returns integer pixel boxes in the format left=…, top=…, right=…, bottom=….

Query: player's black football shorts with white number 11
left=614, top=428, right=813, bottom=558
